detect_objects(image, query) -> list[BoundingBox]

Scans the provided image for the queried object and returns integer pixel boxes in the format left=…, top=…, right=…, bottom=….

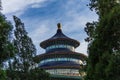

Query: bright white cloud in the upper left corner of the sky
left=2, top=0, right=46, bottom=14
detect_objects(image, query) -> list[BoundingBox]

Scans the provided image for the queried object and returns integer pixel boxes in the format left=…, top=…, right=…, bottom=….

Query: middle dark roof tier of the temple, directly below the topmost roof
left=35, top=51, right=87, bottom=63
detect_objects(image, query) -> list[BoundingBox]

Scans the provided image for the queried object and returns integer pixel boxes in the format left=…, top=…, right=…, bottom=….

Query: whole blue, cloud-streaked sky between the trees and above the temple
left=2, top=0, right=98, bottom=54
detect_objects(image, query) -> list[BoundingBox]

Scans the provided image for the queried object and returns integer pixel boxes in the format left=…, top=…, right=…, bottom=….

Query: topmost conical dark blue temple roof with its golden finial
left=40, top=23, right=80, bottom=49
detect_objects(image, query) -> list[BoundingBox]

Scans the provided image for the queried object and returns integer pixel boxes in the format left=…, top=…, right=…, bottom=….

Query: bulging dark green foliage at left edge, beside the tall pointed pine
left=0, top=13, right=14, bottom=65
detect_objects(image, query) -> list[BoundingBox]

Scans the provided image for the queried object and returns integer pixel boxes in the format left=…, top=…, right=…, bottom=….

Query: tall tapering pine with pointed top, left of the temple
left=13, top=16, right=36, bottom=80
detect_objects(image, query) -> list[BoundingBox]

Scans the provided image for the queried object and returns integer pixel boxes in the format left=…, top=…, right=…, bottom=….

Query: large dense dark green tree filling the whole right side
left=85, top=0, right=120, bottom=80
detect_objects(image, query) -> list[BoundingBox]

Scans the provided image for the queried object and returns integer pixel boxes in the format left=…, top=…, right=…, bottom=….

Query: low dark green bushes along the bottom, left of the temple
left=7, top=68, right=50, bottom=80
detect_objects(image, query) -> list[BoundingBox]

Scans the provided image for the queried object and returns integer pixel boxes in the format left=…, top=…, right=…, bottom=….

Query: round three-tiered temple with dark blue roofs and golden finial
left=37, top=23, right=86, bottom=80
